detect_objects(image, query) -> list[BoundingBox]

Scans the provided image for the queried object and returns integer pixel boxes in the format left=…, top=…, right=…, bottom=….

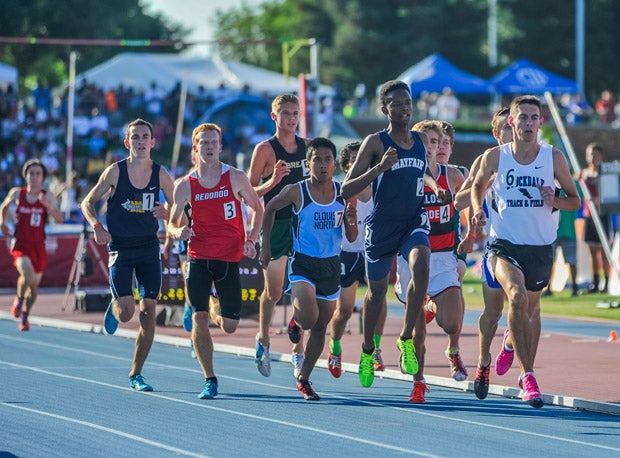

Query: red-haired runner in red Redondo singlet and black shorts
left=168, top=123, right=263, bottom=399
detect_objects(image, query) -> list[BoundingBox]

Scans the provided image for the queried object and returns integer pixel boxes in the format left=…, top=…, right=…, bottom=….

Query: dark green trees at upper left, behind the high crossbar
left=0, top=0, right=188, bottom=94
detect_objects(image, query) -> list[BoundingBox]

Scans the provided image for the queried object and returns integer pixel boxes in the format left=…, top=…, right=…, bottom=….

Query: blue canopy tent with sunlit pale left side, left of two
left=396, top=53, right=492, bottom=97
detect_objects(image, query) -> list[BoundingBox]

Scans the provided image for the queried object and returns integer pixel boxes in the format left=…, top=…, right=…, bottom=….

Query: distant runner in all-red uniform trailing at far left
left=0, top=159, right=63, bottom=331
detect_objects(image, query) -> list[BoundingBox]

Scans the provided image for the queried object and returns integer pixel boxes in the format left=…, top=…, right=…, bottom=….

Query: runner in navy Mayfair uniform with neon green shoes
left=342, top=81, right=450, bottom=394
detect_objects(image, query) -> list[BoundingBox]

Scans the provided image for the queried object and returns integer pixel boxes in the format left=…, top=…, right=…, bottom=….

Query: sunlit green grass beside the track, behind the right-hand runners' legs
left=357, top=273, right=620, bottom=321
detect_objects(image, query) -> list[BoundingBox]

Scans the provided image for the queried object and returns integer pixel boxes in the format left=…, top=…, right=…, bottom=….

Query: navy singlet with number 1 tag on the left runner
left=106, top=159, right=159, bottom=249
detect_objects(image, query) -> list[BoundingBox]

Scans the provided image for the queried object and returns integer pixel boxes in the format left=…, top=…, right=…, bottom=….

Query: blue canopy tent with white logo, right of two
left=490, top=58, right=578, bottom=94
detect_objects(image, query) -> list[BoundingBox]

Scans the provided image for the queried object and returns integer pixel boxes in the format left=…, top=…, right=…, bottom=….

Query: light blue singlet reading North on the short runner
left=293, top=180, right=344, bottom=258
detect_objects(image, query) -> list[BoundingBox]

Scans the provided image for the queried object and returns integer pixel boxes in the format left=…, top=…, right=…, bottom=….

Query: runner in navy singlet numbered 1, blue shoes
left=81, top=119, right=173, bottom=391
